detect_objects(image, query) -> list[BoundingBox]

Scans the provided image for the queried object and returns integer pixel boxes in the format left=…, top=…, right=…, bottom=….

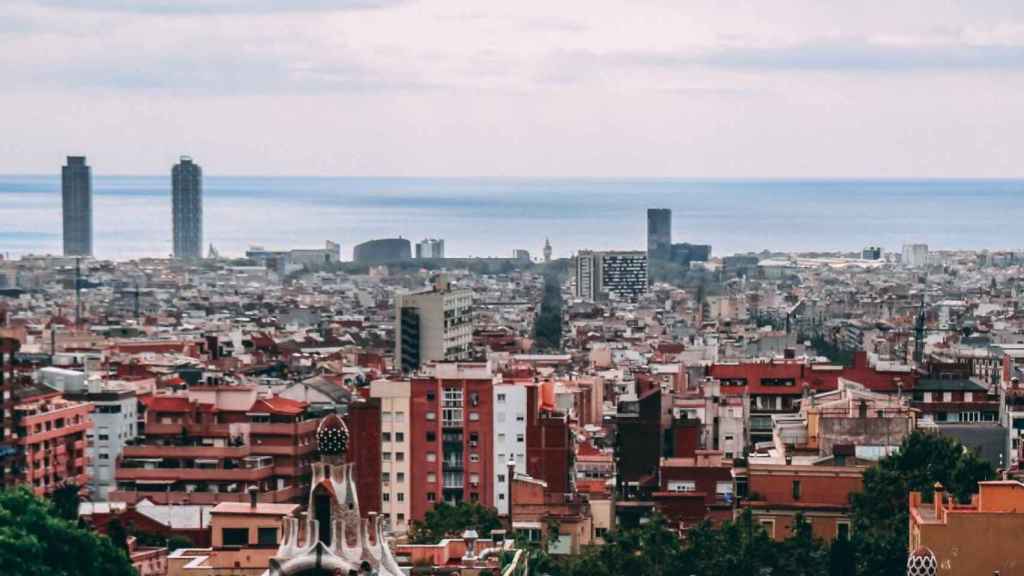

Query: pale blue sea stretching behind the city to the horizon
left=0, top=175, right=1024, bottom=260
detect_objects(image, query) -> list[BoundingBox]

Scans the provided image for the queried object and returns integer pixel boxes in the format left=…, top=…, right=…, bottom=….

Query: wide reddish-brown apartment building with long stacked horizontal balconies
left=111, top=385, right=319, bottom=504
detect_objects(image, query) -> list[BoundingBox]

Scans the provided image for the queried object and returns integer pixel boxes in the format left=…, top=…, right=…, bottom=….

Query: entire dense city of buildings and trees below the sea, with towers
left=0, top=156, right=1024, bottom=576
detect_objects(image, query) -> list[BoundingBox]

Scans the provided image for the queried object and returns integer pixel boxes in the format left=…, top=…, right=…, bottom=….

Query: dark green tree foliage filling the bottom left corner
left=0, top=488, right=135, bottom=576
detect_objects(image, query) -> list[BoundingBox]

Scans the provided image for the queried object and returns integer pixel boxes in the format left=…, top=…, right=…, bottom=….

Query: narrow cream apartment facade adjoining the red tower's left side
left=370, top=380, right=412, bottom=534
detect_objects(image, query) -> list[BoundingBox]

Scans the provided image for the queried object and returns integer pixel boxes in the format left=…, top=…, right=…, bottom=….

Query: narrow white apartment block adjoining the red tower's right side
left=493, top=383, right=526, bottom=516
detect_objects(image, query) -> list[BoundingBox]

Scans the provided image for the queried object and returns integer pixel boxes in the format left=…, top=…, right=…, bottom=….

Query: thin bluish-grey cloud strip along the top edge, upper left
left=28, top=0, right=404, bottom=14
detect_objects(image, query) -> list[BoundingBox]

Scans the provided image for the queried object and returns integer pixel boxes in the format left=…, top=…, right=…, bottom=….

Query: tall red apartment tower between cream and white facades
left=404, top=363, right=495, bottom=520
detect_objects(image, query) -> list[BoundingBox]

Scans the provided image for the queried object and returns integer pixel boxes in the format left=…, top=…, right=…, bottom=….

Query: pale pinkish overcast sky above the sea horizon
left=0, top=0, right=1024, bottom=178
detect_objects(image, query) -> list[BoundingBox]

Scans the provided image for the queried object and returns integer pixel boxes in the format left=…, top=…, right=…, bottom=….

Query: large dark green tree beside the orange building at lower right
left=852, top=431, right=995, bottom=576
